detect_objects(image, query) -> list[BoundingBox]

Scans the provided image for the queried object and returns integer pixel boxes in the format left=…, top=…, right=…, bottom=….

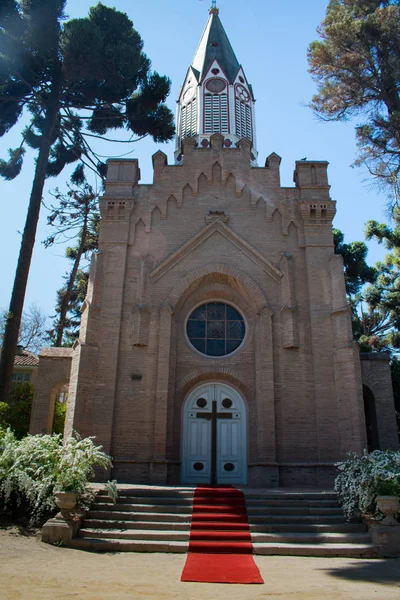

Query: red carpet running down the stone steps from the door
left=181, top=486, right=264, bottom=583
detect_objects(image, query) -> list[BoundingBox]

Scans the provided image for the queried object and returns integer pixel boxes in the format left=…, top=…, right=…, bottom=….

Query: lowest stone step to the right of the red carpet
left=253, top=543, right=377, bottom=558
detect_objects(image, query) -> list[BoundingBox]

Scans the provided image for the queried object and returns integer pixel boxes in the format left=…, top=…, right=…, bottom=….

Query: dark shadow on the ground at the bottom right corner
left=323, top=558, right=400, bottom=584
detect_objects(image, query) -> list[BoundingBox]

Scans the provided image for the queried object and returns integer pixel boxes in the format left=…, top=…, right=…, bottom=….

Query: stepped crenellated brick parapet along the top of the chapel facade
left=100, top=142, right=336, bottom=256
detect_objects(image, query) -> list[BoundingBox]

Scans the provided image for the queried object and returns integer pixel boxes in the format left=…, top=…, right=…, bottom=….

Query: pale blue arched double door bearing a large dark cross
left=182, top=383, right=247, bottom=484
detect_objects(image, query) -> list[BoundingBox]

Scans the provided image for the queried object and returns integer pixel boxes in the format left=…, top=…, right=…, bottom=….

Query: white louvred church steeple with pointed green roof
left=175, top=2, right=257, bottom=164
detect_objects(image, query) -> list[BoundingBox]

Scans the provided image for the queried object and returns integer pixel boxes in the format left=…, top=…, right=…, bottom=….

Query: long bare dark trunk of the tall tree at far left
left=0, top=74, right=61, bottom=402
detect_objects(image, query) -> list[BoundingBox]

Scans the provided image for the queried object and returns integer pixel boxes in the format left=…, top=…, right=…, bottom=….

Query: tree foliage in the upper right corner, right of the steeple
left=308, top=0, right=400, bottom=205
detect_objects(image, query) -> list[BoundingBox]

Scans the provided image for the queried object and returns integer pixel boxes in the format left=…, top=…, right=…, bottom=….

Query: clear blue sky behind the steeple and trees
left=0, top=0, right=385, bottom=322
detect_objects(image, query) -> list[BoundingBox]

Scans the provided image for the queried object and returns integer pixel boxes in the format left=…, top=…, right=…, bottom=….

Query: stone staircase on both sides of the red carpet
left=71, top=485, right=377, bottom=558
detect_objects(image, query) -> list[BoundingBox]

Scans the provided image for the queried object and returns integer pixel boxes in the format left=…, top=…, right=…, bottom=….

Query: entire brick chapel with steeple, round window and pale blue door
left=31, top=3, right=397, bottom=487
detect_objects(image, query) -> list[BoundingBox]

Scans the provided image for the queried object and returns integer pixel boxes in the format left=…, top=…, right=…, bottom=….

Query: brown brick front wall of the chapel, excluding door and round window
left=47, top=135, right=390, bottom=485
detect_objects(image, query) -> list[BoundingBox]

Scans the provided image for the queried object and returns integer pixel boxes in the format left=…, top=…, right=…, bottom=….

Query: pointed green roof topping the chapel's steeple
left=192, top=9, right=240, bottom=83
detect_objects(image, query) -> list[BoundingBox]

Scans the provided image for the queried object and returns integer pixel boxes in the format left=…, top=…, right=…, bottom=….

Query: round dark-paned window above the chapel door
left=186, top=302, right=246, bottom=356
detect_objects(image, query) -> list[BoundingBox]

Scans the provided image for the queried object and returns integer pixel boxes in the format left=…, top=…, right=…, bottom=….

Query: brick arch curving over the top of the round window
left=167, top=263, right=271, bottom=312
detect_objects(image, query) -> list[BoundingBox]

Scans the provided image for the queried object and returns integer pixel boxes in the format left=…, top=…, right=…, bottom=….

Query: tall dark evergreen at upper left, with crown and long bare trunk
left=0, top=0, right=174, bottom=401
